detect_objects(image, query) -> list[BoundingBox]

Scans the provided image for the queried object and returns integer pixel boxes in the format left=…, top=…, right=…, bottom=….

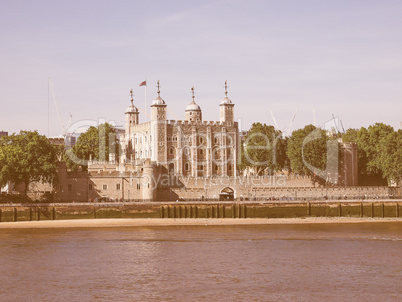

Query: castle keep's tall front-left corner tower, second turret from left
left=150, top=81, right=167, bottom=164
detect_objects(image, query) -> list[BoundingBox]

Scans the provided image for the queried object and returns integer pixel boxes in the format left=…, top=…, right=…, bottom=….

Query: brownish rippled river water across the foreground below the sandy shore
left=0, top=222, right=402, bottom=301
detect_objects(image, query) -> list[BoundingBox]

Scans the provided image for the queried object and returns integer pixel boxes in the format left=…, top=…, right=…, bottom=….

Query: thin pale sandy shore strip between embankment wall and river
left=0, top=217, right=402, bottom=229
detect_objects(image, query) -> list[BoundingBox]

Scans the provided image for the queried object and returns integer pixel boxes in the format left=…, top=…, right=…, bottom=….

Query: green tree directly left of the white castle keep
left=64, top=123, right=118, bottom=171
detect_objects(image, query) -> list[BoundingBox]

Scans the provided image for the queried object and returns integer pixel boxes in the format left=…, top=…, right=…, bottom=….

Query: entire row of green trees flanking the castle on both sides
left=0, top=123, right=402, bottom=193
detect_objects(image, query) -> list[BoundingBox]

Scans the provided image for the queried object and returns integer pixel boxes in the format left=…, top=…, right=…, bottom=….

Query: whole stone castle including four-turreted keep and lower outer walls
left=18, top=81, right=368, bottom=201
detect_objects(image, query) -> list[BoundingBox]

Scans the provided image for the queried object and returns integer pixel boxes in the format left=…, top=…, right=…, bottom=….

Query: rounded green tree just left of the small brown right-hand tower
left=287, top=125, right=339, bottom=184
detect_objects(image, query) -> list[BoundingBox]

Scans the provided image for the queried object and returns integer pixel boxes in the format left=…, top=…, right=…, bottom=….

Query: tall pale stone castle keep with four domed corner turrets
left=111, top=81, right=239, bottom=177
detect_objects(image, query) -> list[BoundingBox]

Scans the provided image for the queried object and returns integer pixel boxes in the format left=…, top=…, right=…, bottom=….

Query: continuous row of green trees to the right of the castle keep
left=239, top=123, right=402, bottom=184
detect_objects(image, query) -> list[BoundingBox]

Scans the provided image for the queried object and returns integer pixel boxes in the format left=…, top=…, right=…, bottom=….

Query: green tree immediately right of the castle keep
left=240, top=123, right=287, bottom=175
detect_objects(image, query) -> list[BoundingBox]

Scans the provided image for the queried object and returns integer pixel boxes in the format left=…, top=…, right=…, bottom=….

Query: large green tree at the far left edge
left=0, top=131, right=57, bottom=194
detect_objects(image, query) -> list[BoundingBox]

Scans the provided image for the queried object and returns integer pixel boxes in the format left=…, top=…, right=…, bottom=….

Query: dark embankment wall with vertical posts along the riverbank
left=0, top=200, right=402, bottom=222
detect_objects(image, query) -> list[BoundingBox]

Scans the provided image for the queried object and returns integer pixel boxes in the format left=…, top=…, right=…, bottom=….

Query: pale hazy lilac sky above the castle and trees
left=0, top=0, right=402, bottom=136
